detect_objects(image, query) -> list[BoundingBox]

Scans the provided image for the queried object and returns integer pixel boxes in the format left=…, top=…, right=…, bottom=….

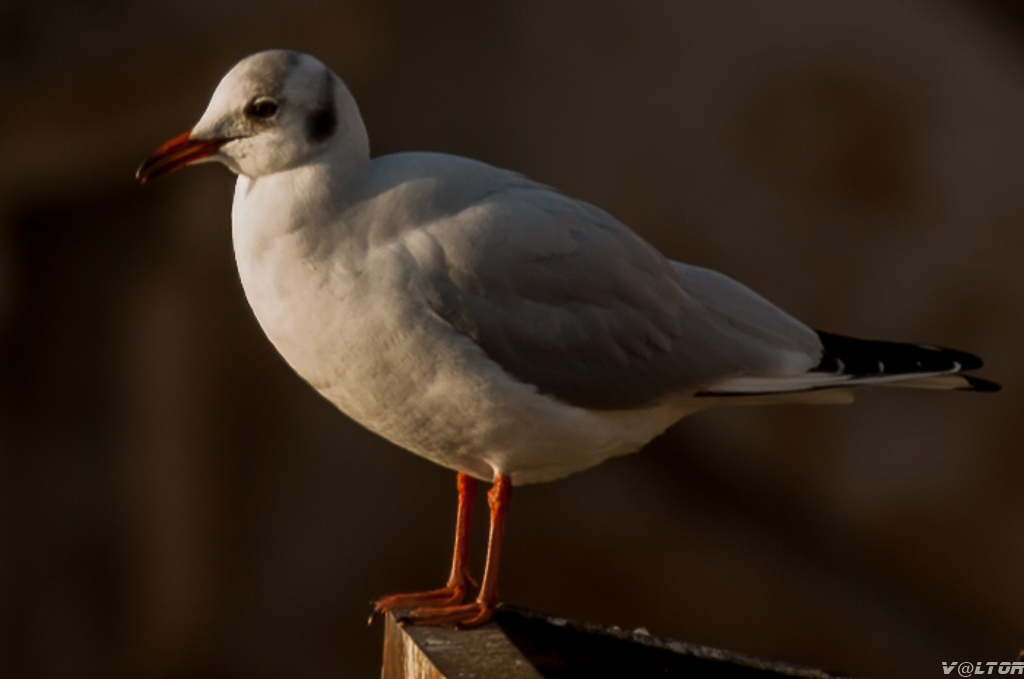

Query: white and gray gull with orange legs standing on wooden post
left=137, top=50, right=998, bottom=627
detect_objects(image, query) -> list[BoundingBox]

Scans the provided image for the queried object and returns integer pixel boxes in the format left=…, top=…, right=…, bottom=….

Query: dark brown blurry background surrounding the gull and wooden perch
left=0, top=0, right=1024, bottom=679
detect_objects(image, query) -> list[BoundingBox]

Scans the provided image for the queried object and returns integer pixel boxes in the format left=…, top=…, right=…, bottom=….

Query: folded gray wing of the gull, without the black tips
left=416, top=179, right=820, bottom=409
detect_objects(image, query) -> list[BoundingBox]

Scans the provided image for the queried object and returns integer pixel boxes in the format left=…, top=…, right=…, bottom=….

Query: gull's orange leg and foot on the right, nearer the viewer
left=403, top=474, right=512, bottom=629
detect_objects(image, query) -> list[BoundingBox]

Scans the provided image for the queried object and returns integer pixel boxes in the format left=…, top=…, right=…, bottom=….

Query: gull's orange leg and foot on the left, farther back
left=374, top=474, right=477, bottom=616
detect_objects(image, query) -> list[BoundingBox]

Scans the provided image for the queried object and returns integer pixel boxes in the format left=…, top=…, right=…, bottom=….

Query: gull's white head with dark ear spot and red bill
left=135, top=49, right=369, bottom=183
